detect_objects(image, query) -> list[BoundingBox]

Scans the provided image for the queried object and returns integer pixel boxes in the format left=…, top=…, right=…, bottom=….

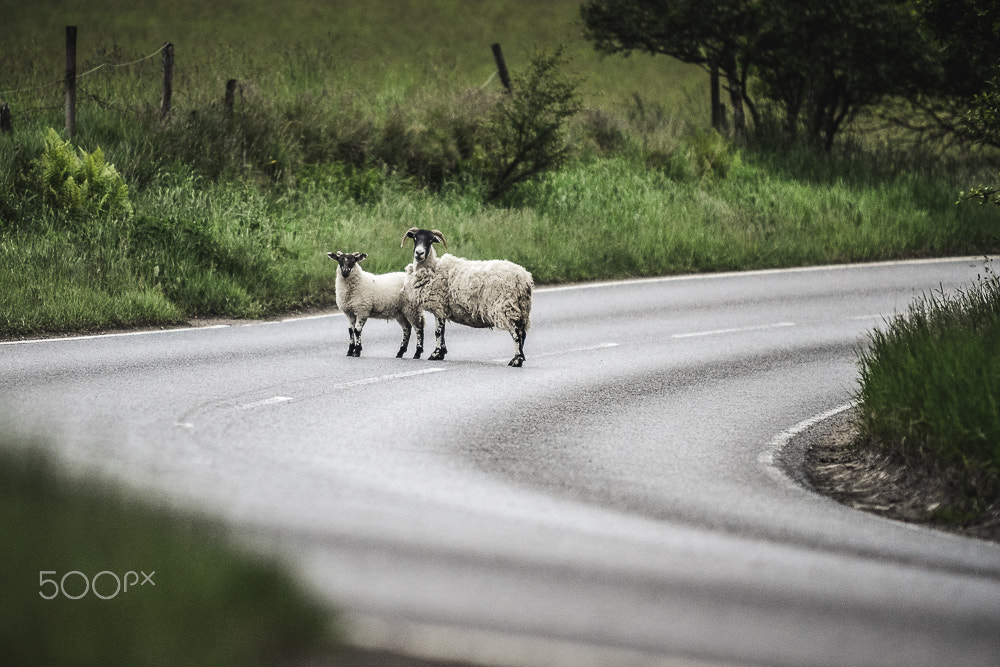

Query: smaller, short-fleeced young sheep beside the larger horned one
left=326, top=250, right=424, bottom=359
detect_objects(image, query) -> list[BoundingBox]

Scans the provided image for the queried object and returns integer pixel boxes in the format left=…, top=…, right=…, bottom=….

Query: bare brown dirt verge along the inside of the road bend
left=800, top=410, right=1000, bottom=542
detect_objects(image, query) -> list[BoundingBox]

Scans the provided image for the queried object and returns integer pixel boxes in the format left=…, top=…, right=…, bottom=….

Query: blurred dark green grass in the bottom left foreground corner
left=0, top=438, right=339, bottom=665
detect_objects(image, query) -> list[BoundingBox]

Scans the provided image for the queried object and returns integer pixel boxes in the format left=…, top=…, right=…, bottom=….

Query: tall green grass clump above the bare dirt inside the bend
left=858, top=265, right=1000, bottom=518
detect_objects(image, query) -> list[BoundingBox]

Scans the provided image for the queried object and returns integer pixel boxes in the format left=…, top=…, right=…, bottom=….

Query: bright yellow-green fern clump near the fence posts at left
left=37, top=128, right=132, bottom=222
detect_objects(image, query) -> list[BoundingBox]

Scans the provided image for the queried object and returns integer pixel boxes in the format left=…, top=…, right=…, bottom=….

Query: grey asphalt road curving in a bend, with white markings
left=0, top=259, right=1000, bottom=665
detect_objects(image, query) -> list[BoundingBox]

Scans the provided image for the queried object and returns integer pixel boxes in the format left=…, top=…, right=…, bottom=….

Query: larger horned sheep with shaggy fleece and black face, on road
left=399, top=227, right=533, bottom=367
